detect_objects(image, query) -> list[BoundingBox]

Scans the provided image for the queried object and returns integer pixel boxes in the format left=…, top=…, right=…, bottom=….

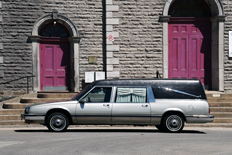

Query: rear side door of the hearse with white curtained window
left=112, top=87, right=151, bottom=124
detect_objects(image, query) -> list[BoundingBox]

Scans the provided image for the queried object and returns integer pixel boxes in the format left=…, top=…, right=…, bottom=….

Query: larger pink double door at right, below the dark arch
left=168, top=18, right=211, bottom=87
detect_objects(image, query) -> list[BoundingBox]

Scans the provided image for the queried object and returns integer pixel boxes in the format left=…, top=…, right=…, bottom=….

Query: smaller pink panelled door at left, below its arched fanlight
left=40, top=42, right=69, bottom=90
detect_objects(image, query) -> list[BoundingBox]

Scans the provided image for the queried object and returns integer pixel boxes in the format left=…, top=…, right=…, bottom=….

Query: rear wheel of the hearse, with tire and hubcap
left=162, top=114, right=184, bottom=132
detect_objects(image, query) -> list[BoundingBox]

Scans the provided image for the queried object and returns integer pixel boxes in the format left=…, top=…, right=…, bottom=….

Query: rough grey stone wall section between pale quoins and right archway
left=113, top=0, right=165, bottom=78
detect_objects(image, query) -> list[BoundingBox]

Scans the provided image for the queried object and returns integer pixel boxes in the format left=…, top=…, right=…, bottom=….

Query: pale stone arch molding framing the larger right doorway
left=159, top=0, right=225, bottom=91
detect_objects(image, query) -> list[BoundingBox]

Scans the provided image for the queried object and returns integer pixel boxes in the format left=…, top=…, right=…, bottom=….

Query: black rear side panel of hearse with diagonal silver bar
left=152, top=83, right=206, bottom=99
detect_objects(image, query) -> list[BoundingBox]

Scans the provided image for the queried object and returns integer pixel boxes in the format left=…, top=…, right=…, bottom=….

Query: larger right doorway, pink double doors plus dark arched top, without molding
left=168, top=0, right=212, bottom=89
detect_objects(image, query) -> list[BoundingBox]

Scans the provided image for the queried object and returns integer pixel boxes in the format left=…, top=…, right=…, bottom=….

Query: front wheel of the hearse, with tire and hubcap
left=46, top=112, right=69, bottom=132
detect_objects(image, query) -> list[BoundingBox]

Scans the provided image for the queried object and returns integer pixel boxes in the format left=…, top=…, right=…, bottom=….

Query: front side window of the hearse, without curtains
left=84, top=87, right=112, bottom=103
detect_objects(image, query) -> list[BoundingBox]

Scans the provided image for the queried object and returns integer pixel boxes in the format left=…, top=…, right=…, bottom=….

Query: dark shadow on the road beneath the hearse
left=14, top=129, right=207, bottom=134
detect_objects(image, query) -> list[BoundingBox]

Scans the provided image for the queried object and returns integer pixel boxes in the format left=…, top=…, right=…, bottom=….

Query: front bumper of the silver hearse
left=21, top=114, right=45, bottom=124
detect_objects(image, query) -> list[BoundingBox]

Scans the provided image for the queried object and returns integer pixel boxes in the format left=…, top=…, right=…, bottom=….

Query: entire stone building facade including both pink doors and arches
left=0, top=0, right=232, bottom=92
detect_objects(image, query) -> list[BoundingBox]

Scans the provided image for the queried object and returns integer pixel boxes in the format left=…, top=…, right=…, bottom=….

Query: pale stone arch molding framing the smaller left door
left=28, top=10, right=81, bottom=92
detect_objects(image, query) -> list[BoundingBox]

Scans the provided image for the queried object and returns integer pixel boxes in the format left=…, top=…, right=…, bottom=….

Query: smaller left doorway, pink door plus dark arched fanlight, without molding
left=39, top=21, right=70, bottom=90
